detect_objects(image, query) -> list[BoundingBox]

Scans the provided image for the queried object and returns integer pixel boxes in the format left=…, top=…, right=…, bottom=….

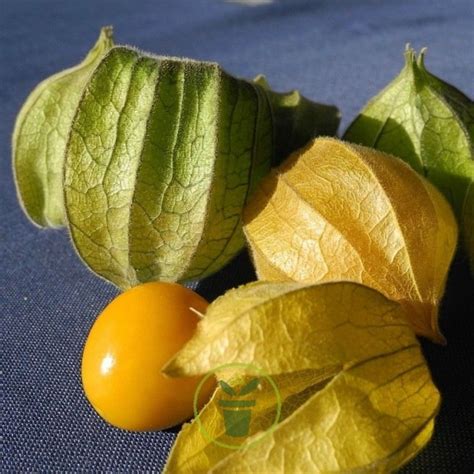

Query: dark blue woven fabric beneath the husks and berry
left=0, top=0, right=474, bottom=473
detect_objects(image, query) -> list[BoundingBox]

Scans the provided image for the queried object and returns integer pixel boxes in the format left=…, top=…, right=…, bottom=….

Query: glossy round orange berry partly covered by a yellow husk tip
left=82, top=282, right=214, bottom=431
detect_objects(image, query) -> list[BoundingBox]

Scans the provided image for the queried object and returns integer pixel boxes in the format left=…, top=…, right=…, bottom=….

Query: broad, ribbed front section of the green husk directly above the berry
left=64, top=47, right=335, bottom=288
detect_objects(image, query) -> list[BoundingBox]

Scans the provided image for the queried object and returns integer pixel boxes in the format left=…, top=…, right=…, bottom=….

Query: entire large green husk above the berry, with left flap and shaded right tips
left=13, top=28, right=339, bottom=289
